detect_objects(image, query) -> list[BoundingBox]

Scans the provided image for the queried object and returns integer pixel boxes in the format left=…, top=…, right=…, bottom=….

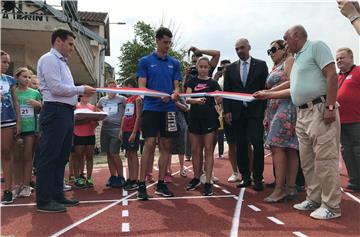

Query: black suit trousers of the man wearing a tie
left=232, top=116, right=264, bottom=181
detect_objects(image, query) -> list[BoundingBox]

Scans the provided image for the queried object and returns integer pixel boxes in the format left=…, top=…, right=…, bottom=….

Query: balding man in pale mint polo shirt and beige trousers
left=284, top=25, right=341, bottom=220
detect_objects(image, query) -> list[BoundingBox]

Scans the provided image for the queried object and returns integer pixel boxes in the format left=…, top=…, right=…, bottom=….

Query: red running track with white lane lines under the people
left=1, top=153, right=360, bottom=237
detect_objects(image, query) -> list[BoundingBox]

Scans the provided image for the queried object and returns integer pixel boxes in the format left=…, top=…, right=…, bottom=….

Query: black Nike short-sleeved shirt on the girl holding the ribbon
left=187, top=78, right=221, bottom=119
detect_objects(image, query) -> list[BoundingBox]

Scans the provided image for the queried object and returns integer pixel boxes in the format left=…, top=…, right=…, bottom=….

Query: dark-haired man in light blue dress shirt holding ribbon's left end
left=36, top=29, right=95, bottom=212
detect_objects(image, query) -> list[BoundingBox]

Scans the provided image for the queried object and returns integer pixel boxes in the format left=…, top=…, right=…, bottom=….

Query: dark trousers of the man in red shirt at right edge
left=341, top=123, right=360, bottom=188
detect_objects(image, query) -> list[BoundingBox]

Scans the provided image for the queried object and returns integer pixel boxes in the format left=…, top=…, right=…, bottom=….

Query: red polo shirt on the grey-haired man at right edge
left=337, top=66, right=360, bottom=123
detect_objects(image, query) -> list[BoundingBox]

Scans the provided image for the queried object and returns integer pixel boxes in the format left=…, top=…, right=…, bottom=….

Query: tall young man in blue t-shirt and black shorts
left=137, top=27, right=181, bottom=200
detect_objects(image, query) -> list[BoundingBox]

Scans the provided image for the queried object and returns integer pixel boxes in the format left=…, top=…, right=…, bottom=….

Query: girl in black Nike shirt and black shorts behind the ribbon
left=186, top=57, right=221, bottom=196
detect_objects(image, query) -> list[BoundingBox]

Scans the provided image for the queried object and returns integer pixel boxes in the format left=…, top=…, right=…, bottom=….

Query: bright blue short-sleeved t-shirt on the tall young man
left=137, top=53, right=181, bottom=112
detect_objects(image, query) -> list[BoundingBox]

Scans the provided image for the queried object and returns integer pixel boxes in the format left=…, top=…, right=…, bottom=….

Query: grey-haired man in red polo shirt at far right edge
left=336, top=48, right=360, bottom=192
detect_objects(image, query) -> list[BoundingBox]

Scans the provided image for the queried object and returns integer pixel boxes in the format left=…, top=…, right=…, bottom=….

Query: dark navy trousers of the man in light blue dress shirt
left=35, top=102, right=74, bottom=205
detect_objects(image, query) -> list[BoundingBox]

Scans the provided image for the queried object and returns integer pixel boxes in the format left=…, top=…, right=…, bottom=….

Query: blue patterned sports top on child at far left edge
left=0, top=74, right=16, bottom=122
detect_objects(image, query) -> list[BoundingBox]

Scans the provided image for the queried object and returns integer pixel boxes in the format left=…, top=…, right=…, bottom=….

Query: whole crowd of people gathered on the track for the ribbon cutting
left=0, top=1, right=360, bottom=219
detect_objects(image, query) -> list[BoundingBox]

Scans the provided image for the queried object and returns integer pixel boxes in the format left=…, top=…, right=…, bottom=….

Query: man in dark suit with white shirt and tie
left=224, top=38, right=268, bottom=191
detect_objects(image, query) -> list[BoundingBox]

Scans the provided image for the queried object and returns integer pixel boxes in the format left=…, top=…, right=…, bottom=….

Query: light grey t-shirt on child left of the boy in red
left=98, top=95, right=126, bottom=129
